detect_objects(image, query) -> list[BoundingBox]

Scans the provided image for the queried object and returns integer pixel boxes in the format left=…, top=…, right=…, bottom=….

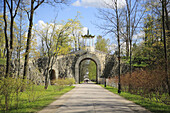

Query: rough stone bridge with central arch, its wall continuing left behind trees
left=5, top=48, right=128, bottom=84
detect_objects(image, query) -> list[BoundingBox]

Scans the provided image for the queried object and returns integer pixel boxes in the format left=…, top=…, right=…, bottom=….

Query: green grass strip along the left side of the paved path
left=0, top=86, right=74, bottom=113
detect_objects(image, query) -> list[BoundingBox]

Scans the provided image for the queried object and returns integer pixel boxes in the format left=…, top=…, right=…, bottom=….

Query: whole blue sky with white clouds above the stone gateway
left=34, top=0, right=143, bottom=52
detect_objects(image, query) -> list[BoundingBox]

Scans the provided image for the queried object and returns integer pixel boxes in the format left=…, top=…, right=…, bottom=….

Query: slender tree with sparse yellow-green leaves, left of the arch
left=37, top=17, right=77, bottom=89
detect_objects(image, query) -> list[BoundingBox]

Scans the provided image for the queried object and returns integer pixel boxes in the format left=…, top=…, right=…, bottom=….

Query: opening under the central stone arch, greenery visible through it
left=79, top=58, right=97, bottom=83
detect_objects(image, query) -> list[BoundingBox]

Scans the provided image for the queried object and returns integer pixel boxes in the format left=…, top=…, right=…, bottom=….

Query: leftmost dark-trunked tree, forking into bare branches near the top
left=3, top=0, right=21, bottom=77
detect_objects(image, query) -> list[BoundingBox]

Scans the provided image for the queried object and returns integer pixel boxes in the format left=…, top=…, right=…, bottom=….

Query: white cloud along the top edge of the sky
left=72, top=0, right=125, bottom=8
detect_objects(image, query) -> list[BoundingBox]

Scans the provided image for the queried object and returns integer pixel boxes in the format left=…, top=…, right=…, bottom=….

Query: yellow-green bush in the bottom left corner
left=0, top=77, right=23, bottom=111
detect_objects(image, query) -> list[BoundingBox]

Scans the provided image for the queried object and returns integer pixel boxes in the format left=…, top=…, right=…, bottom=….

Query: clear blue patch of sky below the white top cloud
left=34, top=0, right=102, bottom=36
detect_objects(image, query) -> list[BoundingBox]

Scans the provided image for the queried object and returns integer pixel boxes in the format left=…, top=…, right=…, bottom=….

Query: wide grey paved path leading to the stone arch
left=38, top=83, right=151, bottom=113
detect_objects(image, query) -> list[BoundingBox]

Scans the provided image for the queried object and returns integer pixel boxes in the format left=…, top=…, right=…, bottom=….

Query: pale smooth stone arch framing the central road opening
left=75, top=53, right=101, bottom=83
